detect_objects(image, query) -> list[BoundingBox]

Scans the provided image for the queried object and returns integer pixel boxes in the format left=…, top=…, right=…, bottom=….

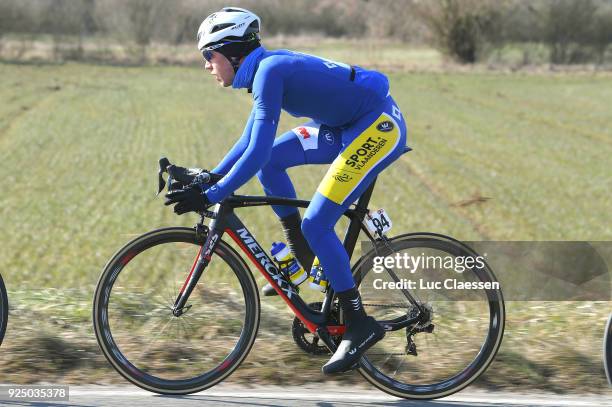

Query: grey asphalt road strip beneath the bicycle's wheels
left=0, top=385, right=612, bottom=407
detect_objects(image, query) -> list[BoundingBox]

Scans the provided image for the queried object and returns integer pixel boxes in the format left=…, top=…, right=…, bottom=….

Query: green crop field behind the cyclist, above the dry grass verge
left=0, top=65, right=612, bottom=287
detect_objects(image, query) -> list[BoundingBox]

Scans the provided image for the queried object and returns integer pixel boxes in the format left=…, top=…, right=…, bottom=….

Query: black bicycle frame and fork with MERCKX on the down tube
left=173, top=178, right=418, bottom=350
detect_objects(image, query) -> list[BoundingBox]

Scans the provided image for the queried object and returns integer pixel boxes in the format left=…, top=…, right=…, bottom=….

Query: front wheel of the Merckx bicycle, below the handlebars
left=93, top=227, right=260, bottom=394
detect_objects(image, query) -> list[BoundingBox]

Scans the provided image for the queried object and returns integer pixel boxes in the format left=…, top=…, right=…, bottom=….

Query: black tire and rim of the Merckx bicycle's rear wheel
left=353, top=233, right=506, bottom=400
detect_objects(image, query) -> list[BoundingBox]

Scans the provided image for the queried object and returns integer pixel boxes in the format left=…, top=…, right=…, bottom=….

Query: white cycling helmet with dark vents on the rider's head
left=198, top=7, right=260, bottom=51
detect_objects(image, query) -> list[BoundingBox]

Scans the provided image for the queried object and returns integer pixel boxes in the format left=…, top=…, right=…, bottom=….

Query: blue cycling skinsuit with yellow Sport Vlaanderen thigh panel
left=205, top=47, right=406, bottom=292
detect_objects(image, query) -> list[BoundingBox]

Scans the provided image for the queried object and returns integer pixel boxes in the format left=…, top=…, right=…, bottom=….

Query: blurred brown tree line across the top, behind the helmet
left=0, top=0, right=612, bottom=64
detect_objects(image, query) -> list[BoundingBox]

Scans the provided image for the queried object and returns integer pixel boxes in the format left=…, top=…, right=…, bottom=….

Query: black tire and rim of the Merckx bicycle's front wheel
left=93, top=227, right=260, bottom=395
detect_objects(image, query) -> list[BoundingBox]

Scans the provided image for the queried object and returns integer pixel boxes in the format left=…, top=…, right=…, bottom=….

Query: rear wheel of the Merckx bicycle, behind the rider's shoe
left=353, top=233, right=506, bottom=399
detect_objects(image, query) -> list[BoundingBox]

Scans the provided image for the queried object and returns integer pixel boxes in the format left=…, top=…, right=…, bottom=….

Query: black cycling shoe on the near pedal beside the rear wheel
left=321, top=317, right=385, bottom=374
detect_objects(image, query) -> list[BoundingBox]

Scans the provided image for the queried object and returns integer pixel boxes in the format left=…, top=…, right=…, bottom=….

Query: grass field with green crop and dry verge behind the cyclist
left=0, top=58, right=612, bottom=391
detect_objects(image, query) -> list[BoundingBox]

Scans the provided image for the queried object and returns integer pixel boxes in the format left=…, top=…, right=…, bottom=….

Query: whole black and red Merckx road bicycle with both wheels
left=93, top=158, right=506, bottom=399
